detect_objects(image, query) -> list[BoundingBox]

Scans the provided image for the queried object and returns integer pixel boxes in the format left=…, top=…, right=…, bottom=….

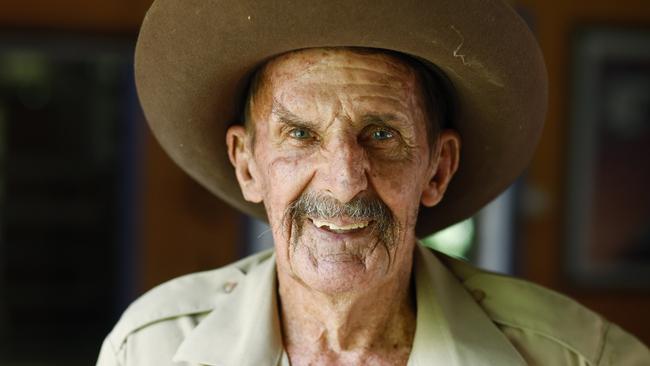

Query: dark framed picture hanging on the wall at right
left=565, top=27, right=650, bottom=289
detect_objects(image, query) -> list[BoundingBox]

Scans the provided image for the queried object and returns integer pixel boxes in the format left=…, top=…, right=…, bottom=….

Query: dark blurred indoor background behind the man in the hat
left=0, top=0, right=650, bottom=366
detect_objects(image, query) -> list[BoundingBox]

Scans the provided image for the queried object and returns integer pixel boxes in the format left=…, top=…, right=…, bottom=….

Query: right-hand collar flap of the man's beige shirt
left=409, top=245, right=526, bottom=366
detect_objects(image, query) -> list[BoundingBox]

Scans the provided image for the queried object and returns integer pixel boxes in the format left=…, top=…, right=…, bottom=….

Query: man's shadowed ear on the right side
left=421, top=129, right=460, bottom=207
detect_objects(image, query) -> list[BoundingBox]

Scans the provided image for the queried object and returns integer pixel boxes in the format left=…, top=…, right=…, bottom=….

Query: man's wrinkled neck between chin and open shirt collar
left=278, top=258, right=415, bottom=365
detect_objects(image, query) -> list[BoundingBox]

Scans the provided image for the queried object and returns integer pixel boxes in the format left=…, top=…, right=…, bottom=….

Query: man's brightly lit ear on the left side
left=226, top=125, right=262, bottom=203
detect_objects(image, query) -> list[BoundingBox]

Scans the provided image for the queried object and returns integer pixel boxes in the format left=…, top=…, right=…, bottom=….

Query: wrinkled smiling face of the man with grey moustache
left=228, top=49, right=456, bottom=293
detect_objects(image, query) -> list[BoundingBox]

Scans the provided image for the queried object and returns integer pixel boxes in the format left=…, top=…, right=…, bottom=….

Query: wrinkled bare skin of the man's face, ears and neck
left=227, top=49, right=460, bottom=363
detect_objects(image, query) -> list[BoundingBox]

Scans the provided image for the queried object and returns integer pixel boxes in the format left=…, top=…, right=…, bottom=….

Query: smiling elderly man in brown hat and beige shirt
left=98, top=0, right=650, bottom=366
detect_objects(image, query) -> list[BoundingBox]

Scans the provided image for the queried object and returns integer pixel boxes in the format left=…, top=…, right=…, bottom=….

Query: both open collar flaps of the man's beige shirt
left=174, top=245, right=525, bottom=366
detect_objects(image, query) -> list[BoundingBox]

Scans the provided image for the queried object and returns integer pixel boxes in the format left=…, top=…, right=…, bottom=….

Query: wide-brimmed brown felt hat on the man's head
left=135, top=0, right=547, bottom=236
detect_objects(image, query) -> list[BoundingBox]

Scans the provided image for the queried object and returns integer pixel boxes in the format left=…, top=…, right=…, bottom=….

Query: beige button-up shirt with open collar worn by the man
left=97, top=246, right=650, bottom=366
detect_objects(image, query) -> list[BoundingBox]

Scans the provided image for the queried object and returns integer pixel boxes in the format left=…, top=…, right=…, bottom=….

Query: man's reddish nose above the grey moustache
left=319, top=138, right=369, bottom=203
